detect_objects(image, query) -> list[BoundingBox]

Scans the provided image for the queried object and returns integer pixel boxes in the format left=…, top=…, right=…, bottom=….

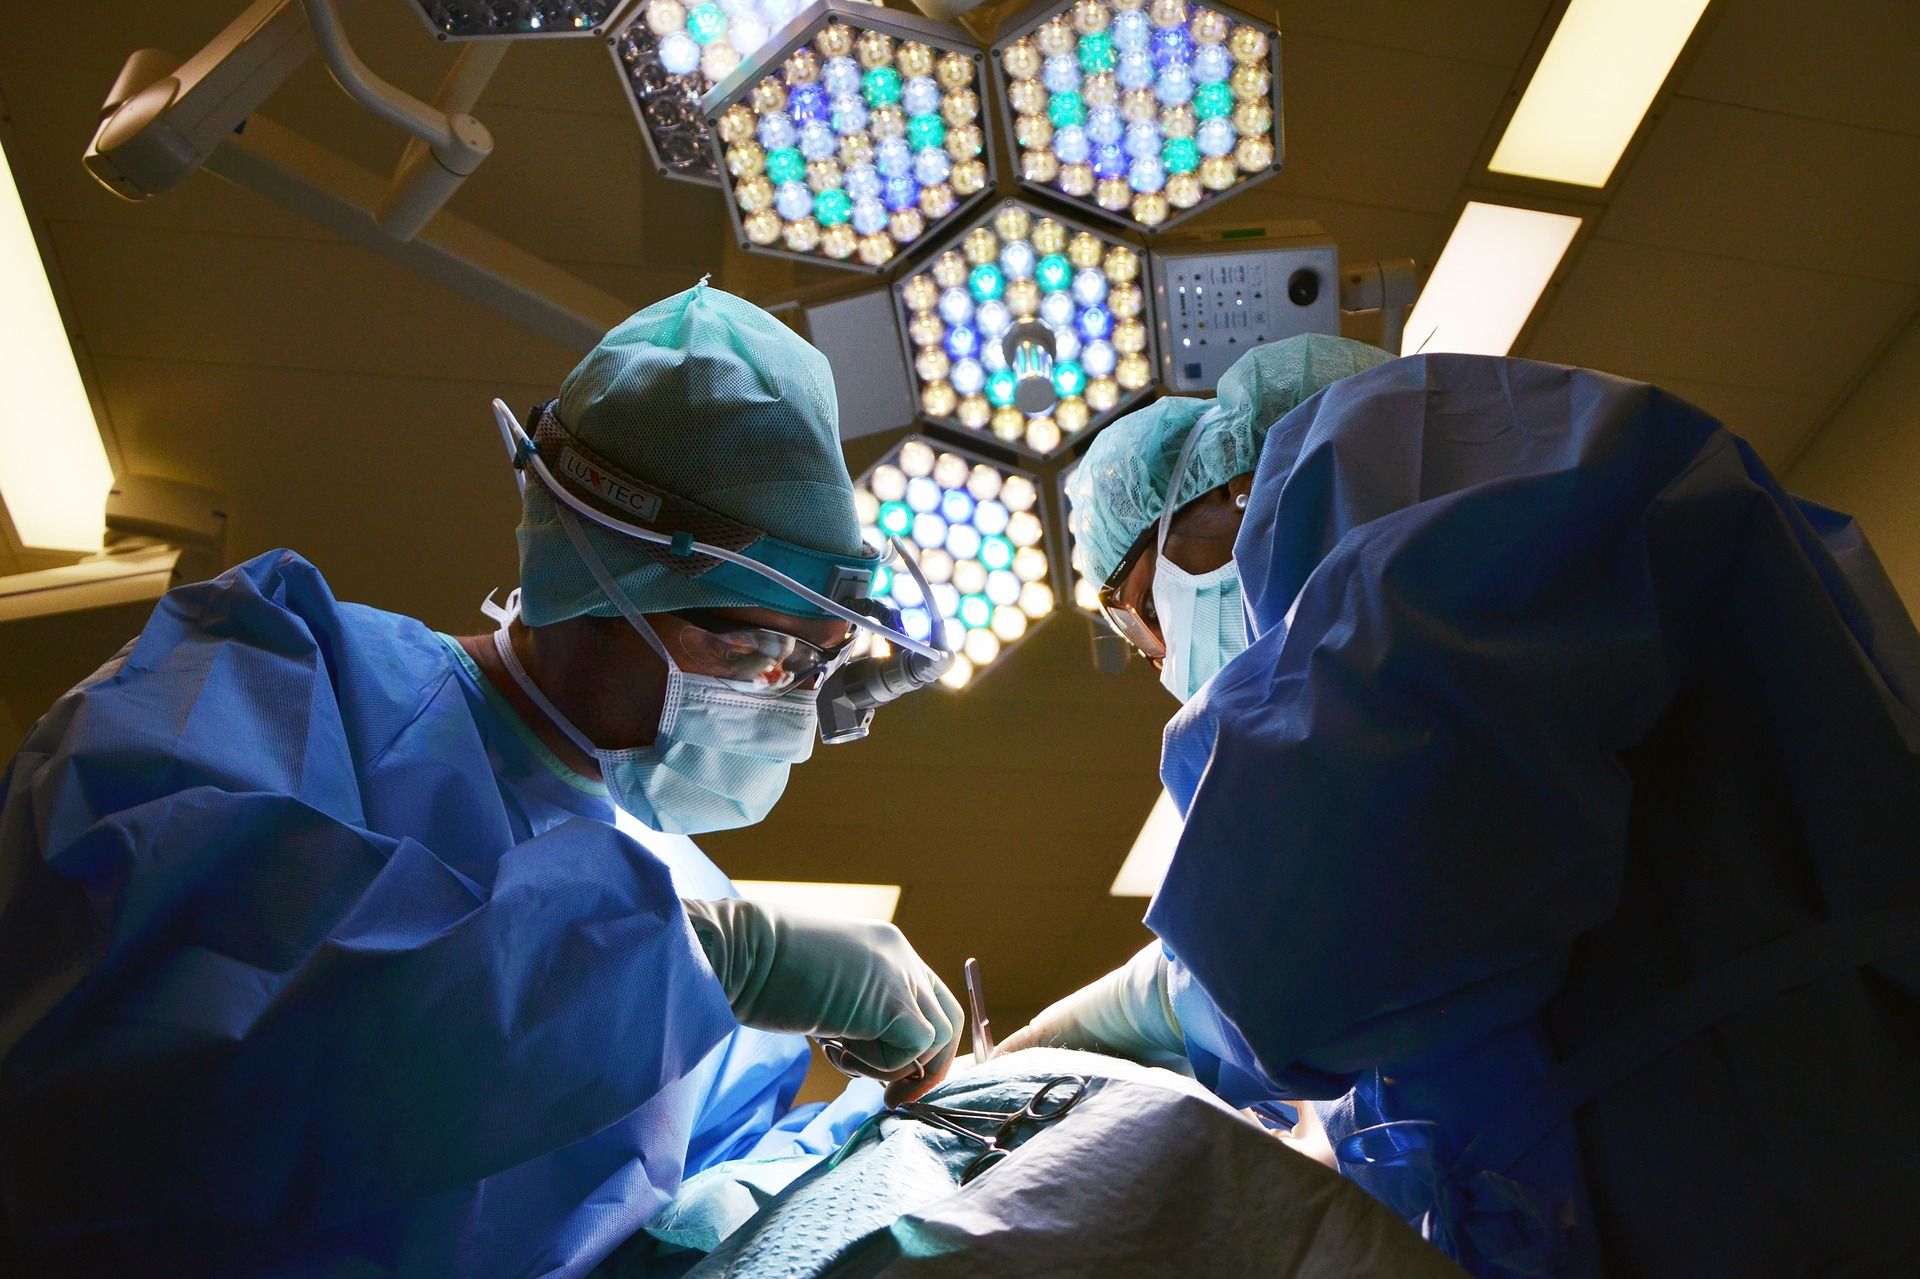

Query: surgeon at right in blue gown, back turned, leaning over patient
left=1004, top=338, right=1920, bottom=1279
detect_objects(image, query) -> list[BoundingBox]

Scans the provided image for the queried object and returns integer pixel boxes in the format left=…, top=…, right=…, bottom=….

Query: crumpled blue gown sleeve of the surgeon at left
left=0, top=553, right=733, bottom=1233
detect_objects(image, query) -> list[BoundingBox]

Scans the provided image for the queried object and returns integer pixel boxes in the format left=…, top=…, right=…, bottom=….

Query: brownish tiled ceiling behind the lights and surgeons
left=0, top=0, right=1920, bottom=1020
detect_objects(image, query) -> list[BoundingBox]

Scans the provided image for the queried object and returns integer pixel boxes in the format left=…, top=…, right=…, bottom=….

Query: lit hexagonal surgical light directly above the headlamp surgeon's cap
left=705, top=0, right=993, bottom=271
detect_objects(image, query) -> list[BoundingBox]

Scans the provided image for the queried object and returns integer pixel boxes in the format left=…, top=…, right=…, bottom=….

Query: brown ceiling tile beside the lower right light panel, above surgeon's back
left=1519, top=236, right=1920, bottom=399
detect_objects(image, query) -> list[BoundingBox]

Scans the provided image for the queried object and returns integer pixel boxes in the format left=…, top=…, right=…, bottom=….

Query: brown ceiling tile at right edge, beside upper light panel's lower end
left=1599, top=98, right=1920, bottom=284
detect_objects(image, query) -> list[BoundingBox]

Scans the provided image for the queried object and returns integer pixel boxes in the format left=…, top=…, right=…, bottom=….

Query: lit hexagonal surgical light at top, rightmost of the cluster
left=993, top=0, right=1281, bottom=230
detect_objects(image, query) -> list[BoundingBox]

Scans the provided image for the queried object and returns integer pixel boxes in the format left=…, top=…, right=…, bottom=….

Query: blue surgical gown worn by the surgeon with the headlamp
left=0, top=551, right=876, bottom=1275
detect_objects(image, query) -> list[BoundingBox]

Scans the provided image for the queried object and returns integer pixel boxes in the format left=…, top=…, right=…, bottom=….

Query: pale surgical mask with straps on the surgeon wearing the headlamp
left=490, top=551, right=820, bottom=835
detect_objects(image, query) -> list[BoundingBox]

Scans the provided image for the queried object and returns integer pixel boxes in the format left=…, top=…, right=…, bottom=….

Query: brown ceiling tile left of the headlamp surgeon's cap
left=94, top=353, right=551, bottom=632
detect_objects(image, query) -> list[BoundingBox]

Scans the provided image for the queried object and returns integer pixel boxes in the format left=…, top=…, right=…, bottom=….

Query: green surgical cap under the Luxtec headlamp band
left=518, top=284, right=860, bottom=626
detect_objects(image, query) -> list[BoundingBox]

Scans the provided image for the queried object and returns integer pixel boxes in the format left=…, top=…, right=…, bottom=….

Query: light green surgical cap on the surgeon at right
left=1068, top=332, right=1392, bottom=586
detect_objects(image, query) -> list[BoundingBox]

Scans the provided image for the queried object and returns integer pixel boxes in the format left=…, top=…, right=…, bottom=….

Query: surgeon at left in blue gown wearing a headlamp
left=0, top=284, right=962, bottom=1275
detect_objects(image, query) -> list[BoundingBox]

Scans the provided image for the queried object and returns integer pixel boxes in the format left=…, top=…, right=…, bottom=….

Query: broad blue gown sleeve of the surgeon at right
left=1148, top=357, right=1910, bottom=1097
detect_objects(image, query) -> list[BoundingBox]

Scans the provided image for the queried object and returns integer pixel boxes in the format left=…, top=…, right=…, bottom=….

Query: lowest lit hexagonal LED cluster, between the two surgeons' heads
left=854, top=436, right=1054, bottom=689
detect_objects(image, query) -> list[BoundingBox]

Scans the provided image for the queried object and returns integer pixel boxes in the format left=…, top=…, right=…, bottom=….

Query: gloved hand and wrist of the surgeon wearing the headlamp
left=682, top=899, right=966, bottom=1104
